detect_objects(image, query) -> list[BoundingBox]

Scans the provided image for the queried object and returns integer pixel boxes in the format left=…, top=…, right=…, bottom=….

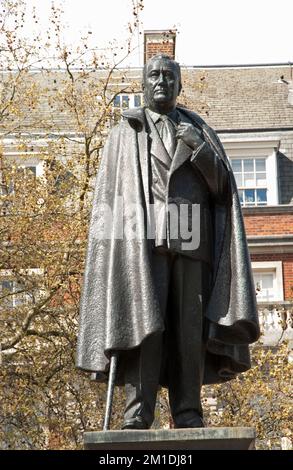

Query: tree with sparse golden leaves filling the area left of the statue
left=0, top=0, right=143, bottom=449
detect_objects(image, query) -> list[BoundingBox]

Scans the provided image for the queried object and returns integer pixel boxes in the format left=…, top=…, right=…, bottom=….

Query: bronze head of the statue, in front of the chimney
left=143, top=54, right=182, bottom=114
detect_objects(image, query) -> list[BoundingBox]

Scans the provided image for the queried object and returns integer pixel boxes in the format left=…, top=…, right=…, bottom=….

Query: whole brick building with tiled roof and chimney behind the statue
left=0, top=26, right=293, bottom=452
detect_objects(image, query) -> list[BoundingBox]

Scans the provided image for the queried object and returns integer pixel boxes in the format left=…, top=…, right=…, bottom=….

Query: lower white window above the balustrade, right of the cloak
left=252, top=261, right=284, bottom=302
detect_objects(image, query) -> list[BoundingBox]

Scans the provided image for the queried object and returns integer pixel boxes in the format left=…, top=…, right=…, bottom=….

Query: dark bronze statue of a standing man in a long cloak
left=77, top=55, right=259, bottom=429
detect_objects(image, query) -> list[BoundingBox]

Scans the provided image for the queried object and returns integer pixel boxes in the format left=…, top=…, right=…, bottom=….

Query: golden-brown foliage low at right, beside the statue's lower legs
left=204, top=343, right=293, bottom=449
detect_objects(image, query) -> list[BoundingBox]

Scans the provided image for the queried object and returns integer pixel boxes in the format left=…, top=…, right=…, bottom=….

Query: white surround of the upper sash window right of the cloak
left=222, top=139, right=280, bottom=207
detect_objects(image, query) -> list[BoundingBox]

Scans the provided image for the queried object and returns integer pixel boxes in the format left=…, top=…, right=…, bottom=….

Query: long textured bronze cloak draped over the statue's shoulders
left=77, top=108, right=260, bottom=383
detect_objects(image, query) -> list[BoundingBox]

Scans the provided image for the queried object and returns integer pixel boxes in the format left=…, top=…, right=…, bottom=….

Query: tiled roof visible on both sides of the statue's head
left=0, top=64, right=293, bottom=136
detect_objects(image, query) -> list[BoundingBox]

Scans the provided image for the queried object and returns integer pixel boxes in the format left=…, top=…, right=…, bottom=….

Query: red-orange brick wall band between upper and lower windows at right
left=244, top=213, right=293, bottom=236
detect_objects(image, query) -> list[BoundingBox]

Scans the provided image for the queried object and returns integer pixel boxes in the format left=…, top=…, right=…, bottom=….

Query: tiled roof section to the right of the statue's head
left=179, top=65, right=293, bottom=130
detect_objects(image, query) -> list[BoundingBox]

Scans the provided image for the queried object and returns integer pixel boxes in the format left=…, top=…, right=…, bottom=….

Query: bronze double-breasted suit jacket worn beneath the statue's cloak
left=146, top=106, right=228, bottom=264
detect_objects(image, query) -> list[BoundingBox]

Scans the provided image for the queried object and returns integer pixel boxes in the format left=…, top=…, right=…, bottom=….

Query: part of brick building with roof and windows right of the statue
left=189, top=64, right=293, bottom=343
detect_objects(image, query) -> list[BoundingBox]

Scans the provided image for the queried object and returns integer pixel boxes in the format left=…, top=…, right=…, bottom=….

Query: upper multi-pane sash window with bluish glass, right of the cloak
left=231, top=158, right=267, bottom=206
